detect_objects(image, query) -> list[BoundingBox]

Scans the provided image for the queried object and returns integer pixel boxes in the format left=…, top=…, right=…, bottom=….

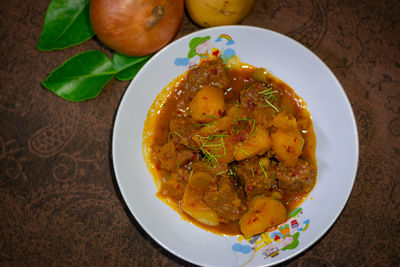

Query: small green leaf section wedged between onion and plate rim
left=113, top=53, right=151, bottom=81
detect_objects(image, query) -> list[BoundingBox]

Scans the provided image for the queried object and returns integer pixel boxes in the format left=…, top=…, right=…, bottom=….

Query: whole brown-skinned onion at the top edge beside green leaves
left=90, top=0, right=184, bottom=57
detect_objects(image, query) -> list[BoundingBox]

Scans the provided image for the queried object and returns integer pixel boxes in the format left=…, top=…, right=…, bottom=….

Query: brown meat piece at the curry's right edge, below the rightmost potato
left=276, top=159, right=317, bottom=193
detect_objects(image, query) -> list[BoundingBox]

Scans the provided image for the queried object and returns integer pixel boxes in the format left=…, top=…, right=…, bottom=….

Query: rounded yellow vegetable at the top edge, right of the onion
left=185, top=0, right=254, bottom=27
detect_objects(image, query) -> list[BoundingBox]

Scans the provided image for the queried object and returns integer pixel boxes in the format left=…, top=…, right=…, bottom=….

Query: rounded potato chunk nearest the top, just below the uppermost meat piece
left=189, top=86, right=225, bottom=123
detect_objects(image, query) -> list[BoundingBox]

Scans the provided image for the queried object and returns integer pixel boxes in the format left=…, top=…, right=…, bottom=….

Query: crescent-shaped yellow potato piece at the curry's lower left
left=181, top=172, right=219, bottom=226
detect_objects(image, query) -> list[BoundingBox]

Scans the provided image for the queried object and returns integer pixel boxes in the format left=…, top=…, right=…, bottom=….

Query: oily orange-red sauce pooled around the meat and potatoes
left=143, top=59, right=316, bottom=235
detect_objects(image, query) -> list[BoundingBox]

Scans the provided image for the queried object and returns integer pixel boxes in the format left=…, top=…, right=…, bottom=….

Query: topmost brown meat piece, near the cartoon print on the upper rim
left=186, top=58, right=230, bottom=98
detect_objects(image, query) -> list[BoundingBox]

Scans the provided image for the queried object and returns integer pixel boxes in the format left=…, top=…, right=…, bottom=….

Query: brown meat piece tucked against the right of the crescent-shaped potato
left=203, top=175, right=241, bottom=223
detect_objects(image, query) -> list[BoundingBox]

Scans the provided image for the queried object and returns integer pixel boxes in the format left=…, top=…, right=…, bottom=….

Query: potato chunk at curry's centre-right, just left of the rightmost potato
left=233, top=127, right=271, bottom=161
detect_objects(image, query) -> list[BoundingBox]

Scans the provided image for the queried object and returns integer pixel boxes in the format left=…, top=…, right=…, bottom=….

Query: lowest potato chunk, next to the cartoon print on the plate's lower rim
left=239, top=197, right=287, bottom=237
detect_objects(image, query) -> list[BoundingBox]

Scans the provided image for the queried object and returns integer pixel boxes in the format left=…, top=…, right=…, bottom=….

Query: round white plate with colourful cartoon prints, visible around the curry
left=112, top=26, right=358, bottom=266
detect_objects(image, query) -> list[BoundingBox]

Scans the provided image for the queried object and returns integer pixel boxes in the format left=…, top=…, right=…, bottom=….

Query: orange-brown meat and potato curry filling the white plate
left=143, top=58, right=317, bottom=237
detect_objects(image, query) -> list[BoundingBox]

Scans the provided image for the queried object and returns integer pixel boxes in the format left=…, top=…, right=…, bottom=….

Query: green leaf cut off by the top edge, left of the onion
left=38, top=0, right=94, bottom=51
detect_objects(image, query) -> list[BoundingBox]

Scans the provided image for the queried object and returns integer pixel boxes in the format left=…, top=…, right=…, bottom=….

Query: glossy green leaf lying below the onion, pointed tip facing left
left=42, top=50, right=116, bottom=102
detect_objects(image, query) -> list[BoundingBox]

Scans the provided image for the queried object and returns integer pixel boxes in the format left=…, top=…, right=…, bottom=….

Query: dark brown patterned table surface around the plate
left=0, top=0, right=400, bottom=266
